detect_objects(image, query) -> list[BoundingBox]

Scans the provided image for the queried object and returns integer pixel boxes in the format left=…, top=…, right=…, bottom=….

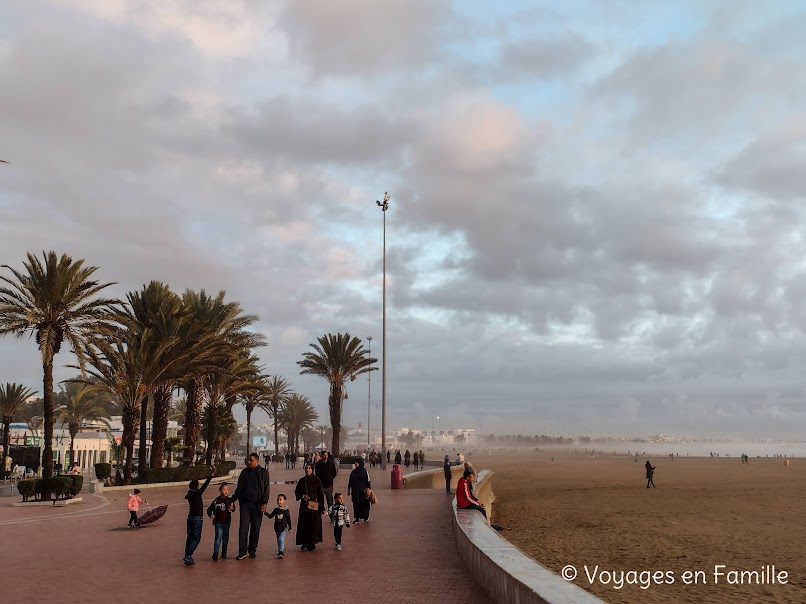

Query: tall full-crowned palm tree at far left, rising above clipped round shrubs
left=0, top=251, right=118, bottom=488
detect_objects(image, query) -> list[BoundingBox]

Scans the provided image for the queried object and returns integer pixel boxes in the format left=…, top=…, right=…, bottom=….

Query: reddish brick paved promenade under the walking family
left=0, top=464, right=491, bottom=604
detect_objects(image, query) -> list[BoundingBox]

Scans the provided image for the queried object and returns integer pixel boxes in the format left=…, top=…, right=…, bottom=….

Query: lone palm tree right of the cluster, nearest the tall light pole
left=297, top=333, right=378, bottom=455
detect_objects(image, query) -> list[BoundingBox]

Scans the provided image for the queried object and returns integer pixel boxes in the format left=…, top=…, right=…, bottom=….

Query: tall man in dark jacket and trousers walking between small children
left=230, top=453, right=269, bottom=560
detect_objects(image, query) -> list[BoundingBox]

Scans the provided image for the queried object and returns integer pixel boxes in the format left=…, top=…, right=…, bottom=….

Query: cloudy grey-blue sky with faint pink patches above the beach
left=0, top=0, right=806, bottom=438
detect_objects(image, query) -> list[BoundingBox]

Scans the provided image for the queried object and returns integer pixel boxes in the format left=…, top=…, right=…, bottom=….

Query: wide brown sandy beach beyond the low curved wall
left=480, top=451, right=806, bottom=603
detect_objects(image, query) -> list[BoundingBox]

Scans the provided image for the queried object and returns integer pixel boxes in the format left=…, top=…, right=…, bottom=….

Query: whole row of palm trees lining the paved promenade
left=0, top=252, right=377, bottom=481
